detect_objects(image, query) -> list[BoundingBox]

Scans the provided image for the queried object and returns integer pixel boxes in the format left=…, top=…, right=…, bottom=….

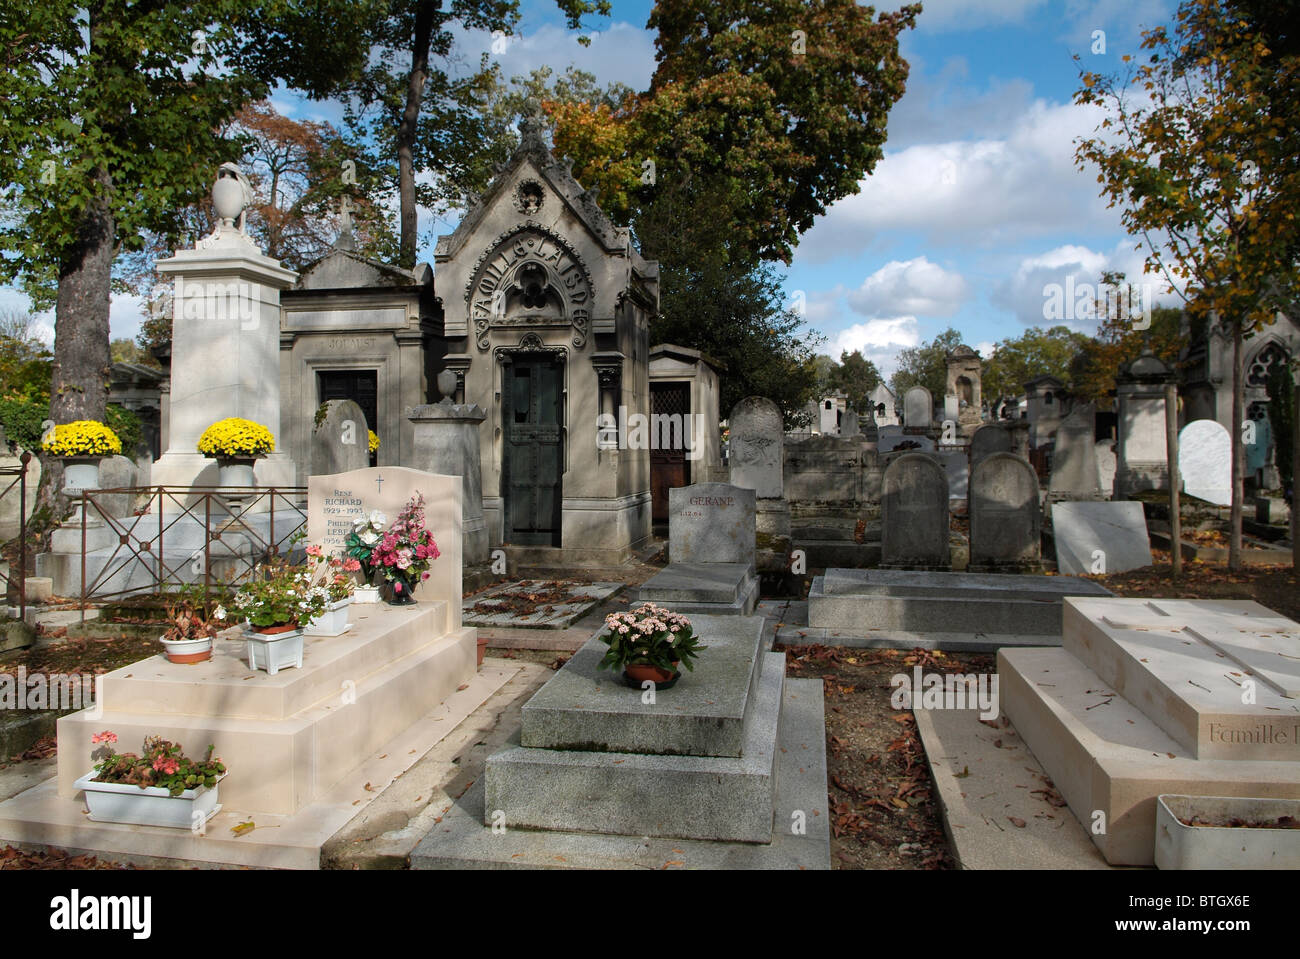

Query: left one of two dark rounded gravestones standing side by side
left=880, top=454, right=949, bottom=569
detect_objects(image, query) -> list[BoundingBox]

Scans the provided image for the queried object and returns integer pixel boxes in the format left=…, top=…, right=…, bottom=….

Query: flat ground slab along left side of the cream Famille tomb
left=913, top=710, right=1110, bottom=869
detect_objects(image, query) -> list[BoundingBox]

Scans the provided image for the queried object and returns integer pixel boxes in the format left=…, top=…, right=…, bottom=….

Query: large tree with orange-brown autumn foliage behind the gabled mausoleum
left=549, top=0, right=920, bottom=262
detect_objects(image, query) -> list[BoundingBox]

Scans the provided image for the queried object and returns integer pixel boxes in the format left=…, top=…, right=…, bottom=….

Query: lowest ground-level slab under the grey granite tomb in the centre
left=411, top=680, right=831, bottom=869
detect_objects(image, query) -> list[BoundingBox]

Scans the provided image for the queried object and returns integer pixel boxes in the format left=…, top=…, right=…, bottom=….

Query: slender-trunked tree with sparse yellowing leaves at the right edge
left=1075, top=0, right=1300, bottom=569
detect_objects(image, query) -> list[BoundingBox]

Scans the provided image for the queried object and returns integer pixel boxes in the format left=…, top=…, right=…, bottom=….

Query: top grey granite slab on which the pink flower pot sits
left=520, top=616, right=763, bottom=756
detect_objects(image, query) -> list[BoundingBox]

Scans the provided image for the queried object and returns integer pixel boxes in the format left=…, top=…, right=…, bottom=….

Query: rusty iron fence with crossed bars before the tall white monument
left=75, top=486, right=307, bottom=617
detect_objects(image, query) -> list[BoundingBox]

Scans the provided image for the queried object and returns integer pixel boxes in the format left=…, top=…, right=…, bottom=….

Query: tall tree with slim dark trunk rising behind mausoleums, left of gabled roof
left=345, top=0, right=611, bottom=268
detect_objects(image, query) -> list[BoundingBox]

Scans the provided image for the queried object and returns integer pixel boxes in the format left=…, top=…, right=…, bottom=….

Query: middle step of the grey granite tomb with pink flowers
left=484, top=654, right=785, bottom=842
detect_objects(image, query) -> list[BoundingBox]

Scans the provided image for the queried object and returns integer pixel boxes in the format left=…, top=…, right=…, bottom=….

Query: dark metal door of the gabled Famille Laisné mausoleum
left=502, top=356, right=564, bottom=546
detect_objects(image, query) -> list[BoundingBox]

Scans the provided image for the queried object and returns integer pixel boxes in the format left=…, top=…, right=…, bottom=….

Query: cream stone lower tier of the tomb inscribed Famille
left=997, top=648, right=1300, bottom=865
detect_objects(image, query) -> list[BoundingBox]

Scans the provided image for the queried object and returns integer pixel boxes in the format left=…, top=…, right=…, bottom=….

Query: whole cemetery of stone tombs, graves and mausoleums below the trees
left=0, top=0, right=1300, bottom=894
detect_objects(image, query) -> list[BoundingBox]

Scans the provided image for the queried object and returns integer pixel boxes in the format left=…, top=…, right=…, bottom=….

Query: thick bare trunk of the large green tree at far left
left=35, top=170, right=116, bottom=529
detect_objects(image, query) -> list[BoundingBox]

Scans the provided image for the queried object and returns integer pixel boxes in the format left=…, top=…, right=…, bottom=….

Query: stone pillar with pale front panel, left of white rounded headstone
left=1115, top=347, right=1174, bottom=499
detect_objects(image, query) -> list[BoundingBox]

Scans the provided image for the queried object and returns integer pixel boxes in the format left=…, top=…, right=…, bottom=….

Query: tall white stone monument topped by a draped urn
left=150, top=164, right=298, bottom=486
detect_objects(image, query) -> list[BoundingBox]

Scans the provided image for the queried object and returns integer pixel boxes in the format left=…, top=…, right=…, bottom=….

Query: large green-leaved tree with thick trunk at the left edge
left=0, top=0, right=373, bottom=522
